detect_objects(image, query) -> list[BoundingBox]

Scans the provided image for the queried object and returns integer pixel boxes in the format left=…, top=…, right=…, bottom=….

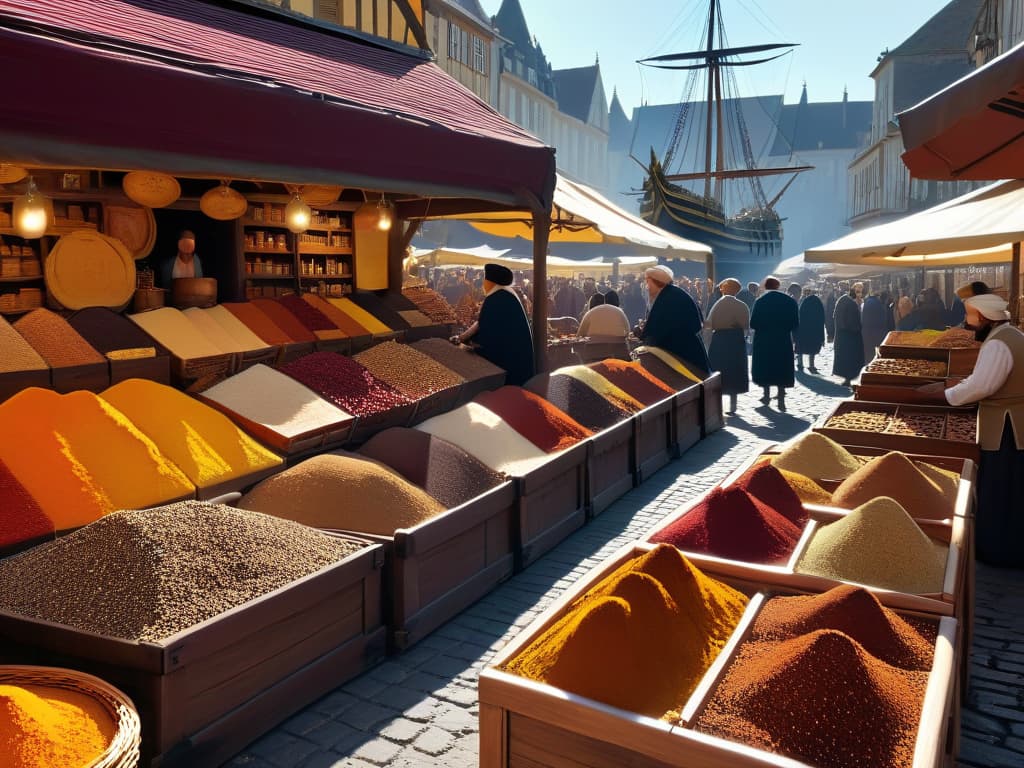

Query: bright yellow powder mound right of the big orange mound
left=100, top=379, right=283, bottom=488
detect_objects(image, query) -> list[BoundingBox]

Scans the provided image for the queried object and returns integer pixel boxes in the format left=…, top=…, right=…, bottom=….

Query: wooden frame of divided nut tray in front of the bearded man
left=813, top=400, right=980, bottom=463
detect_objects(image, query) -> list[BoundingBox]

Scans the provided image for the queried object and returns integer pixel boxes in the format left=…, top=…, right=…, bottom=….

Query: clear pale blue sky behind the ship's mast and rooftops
left=480, top=0, right=948, bottom=115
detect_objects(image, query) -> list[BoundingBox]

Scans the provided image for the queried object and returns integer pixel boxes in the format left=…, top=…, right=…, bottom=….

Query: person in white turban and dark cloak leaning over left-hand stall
left=634, top=264, right=708, bottom=372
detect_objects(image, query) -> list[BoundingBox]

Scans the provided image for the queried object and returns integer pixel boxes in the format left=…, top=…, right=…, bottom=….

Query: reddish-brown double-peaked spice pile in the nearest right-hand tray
left=694, top=588, right=935, bottom=768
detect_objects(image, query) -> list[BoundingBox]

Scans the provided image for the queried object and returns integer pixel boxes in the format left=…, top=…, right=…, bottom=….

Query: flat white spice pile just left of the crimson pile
left=203, top=364, right=353, bottom=438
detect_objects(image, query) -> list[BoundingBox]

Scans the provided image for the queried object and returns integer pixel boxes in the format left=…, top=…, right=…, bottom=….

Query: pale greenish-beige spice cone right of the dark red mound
left=797, top=497, right=949, bottom=594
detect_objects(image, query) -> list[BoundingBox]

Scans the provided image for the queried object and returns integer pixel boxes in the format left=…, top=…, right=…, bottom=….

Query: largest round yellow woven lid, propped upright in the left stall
left=45, top=229, right=135, bottom=309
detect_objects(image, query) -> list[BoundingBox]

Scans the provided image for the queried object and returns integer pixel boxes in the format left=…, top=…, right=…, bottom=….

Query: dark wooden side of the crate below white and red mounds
left=515, top=440, right=590, bottom=570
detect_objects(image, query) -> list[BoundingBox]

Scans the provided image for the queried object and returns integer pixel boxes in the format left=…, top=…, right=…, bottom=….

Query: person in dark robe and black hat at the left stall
left=452, top=264, right=534, bottom=386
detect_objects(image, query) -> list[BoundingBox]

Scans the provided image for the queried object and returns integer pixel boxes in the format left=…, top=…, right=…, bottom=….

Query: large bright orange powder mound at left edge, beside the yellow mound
left=0, top=387, right=196, bottom=530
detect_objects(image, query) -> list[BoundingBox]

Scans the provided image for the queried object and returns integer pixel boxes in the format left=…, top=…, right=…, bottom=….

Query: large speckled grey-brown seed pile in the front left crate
left=0, top=502, right=362, bottom=642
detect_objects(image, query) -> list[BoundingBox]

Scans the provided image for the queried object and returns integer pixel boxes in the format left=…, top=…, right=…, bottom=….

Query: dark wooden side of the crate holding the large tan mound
left=327, top=481, right=517, bottom=651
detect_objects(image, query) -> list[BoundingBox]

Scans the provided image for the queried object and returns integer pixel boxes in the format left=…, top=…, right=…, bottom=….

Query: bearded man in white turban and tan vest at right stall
left=918, top=283, right=1024, bottom=568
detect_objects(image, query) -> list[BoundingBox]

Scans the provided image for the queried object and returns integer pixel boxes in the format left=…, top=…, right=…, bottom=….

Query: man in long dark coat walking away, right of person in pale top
left=751, top=276, right=800, bottom=411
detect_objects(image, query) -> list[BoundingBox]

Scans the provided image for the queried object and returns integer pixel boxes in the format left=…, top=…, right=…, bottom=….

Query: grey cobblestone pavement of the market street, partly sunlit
left=228, top=353, right=1024, bottom=768
